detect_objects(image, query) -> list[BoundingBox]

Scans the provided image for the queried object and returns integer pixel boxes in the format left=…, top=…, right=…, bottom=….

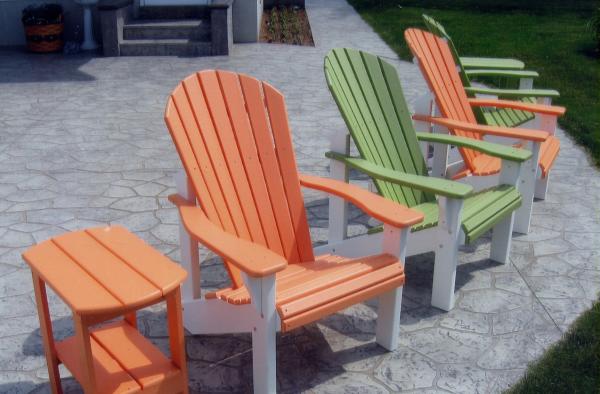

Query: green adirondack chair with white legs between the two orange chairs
left=319, top=49, right=531, bottom=310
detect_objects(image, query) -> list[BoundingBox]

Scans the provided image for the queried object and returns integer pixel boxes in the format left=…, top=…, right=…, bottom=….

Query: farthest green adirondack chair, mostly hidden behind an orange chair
left=419, top=14, right=560, bottom=127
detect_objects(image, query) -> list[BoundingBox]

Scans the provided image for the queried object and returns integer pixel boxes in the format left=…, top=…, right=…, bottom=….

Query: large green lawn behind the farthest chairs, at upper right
left=349, top=0, right=600, bottom=164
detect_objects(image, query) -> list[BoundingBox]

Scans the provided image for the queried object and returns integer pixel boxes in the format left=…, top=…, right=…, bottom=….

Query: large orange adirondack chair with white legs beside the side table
left=165, top=71, right=423, bottom=393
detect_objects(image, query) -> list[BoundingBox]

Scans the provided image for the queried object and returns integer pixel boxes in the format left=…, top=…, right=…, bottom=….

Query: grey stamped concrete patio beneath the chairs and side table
left=0, top=0, right=600, bottom=393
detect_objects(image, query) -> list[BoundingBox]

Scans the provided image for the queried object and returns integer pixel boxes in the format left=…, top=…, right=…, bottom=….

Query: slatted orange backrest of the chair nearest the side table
left=165, top=71, right=314, bottom=287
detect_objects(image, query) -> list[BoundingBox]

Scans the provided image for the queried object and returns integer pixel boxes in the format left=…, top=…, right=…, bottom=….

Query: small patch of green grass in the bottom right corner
left=507, top=302, right=600, bottom=394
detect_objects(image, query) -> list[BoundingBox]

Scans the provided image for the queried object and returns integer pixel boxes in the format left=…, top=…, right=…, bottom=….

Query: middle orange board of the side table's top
left=52, top=231, right=162, bottom=307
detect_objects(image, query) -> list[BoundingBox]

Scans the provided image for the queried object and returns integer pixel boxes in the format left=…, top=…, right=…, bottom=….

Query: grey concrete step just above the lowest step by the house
left=123, top=19, right=210, bottom=41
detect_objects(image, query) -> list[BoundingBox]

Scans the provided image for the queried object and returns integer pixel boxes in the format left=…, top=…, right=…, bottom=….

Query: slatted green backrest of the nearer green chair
left=325, top=49, right=435, bottom=207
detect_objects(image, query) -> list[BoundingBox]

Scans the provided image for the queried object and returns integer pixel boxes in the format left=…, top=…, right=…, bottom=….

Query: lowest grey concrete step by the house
left=120, top=39, right=212, bottom=56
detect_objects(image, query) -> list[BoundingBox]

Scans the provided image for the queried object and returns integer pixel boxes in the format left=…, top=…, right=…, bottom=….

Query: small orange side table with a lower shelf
left=23, top=226, right=188, bottom=393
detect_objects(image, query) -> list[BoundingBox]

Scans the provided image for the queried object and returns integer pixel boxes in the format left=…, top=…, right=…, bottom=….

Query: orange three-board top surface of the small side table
left=23, top=226, right=187, bottom=314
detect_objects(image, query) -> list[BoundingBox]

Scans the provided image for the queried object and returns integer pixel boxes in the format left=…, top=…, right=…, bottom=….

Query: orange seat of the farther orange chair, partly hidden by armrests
left=452, top=135, right=560, bottom=180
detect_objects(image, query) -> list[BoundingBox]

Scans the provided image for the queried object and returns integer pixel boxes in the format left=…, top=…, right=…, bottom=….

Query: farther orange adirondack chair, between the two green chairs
left=404, top=28, right=565, bottom=233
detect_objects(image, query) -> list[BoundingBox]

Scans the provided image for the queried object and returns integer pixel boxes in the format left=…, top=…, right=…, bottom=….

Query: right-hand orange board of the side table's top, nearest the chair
left=86, top=226, right=186, bottom=295
